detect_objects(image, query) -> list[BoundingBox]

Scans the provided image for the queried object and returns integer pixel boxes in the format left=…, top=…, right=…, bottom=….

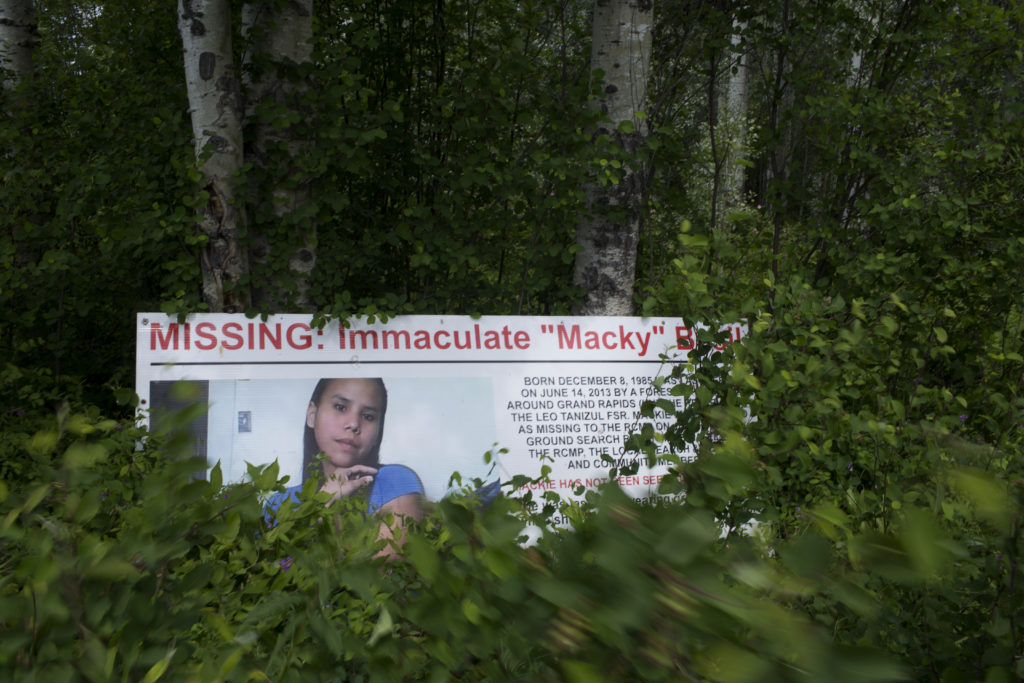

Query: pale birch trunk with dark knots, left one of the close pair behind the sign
left=178, top=0, right=251, bottom=312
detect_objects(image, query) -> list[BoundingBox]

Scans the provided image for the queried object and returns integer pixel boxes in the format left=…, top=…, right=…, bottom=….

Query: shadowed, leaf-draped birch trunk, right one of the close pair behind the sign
left=242, top=0, right=316, bottom=310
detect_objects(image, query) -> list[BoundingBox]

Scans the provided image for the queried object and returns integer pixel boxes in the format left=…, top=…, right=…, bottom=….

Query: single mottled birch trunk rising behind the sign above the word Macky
left=572, top=0, right=653, bottom=315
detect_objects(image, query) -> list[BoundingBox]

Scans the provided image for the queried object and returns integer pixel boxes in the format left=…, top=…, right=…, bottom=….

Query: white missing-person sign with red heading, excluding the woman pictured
left=136, top=313, right=743, bottom=511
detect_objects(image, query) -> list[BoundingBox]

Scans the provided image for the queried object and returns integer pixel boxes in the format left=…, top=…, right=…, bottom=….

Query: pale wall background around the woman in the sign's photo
left=150, top=377, right=502, bottom=501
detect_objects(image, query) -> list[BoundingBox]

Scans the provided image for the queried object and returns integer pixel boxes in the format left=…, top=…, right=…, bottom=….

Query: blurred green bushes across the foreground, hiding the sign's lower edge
left=0, top=385, right=1021, bottom=681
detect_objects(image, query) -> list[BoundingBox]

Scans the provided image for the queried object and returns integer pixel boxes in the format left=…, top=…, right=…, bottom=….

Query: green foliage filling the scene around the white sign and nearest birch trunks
left=0, top=0, right=1024, bottom=681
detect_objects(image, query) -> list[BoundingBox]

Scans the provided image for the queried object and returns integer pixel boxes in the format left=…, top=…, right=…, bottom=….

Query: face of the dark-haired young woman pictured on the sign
left=306, top=379, right=384, bottom=475
